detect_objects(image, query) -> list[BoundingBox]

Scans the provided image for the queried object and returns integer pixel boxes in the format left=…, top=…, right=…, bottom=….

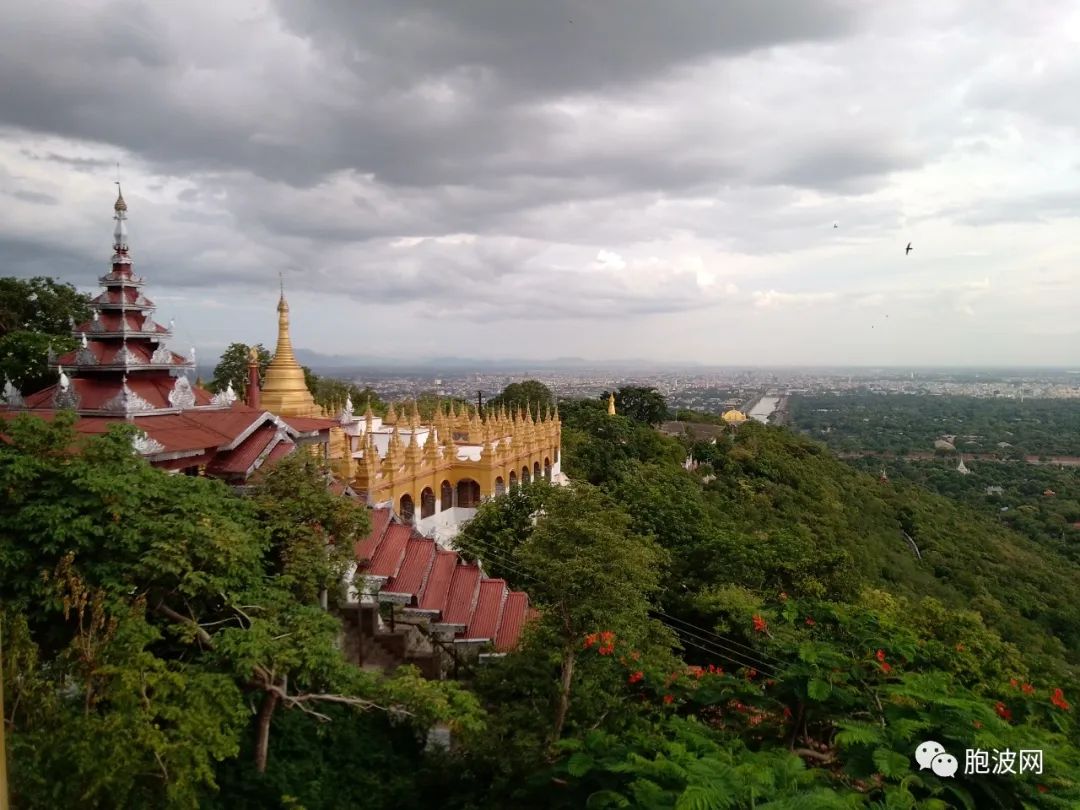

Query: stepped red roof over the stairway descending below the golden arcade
left=355, top=509, right=530, bottom=652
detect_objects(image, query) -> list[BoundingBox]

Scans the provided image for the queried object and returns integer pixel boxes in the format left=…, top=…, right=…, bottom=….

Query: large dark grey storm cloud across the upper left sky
left=0, top=0, right=853, bottom=186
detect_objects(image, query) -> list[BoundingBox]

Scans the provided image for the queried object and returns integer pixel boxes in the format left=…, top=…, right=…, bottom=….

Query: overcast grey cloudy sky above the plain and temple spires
left=0, top=0, right=1080, bottom=365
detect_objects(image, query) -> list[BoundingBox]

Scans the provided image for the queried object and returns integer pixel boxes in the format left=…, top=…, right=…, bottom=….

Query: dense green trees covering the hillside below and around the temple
left=0, top=390, right=1080, bottom=810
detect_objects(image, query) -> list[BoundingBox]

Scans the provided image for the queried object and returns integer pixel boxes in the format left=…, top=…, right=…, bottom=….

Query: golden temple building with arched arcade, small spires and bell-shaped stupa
left=255, top=291, right=566, bottom=541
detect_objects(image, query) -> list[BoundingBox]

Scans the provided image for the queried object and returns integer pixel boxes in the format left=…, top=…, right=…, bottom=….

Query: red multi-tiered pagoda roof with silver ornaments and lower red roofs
left=0, top=193, right=334, bottom=481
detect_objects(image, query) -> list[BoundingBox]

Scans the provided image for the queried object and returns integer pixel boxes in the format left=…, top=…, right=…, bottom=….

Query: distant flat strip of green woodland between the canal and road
left=788, top=393, right=1080, bottom=458
